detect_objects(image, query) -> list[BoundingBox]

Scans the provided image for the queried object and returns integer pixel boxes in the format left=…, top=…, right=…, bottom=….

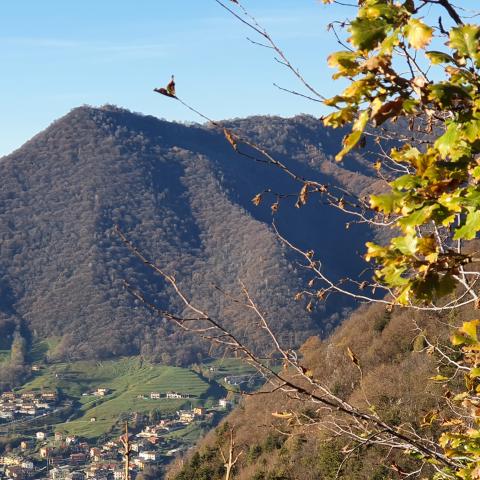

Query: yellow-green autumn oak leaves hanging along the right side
left=324, top=0, right=480, bottom=480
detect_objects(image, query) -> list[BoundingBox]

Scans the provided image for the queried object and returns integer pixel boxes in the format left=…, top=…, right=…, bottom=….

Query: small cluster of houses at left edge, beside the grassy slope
left=0, top=391, right=58, bottom=422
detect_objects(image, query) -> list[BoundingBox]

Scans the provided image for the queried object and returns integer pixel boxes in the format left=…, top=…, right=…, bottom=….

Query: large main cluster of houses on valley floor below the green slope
left=0, top=399, right=232, bottom=480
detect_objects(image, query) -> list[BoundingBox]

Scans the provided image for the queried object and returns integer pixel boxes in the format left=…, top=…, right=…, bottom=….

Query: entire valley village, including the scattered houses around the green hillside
left=0, top=388, right=231, bottom=480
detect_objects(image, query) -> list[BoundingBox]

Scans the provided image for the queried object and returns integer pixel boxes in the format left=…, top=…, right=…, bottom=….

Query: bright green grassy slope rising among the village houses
left=18, top=357, right=209, bottom=438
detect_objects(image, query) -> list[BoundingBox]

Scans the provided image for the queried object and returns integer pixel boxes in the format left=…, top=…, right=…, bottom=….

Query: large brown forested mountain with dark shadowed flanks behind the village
left=0, top=106, right=374, bottom=364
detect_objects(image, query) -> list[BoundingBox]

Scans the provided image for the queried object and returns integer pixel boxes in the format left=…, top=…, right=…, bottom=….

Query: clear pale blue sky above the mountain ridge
left=0, top=0, right=477, bottom=155
